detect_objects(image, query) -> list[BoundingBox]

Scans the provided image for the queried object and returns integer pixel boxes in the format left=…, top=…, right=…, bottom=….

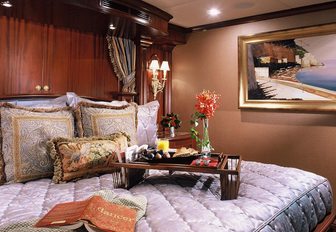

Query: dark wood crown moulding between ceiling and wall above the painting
left=188, top=1, right=336, bottom=31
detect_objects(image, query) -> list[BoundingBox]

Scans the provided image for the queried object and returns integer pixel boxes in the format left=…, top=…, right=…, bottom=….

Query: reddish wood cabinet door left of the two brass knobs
left=0, top=17, right=45, bottom=96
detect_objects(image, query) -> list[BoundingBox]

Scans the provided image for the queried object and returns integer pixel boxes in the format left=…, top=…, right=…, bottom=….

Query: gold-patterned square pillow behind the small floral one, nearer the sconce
left=76, top=102, right=137, bottom=145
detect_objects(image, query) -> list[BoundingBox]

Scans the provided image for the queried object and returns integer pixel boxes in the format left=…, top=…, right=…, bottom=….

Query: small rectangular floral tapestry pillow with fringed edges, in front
left=48, top=133, right=128, bottom=183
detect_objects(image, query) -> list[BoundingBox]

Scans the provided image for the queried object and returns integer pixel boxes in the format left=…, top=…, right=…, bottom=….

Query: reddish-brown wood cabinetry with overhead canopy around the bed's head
left=0, top=0, right=185, bottom=104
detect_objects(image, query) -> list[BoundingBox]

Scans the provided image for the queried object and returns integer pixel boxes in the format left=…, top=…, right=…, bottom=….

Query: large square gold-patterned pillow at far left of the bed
left=0, top=103, right=74, bottom=182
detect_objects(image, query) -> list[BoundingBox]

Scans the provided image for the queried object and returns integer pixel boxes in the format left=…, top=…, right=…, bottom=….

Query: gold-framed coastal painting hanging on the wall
left=238, top=23, right=336, bottom=111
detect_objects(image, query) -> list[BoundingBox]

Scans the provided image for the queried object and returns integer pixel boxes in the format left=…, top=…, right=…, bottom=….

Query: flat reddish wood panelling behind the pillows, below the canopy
left=0, top=16, right=119, bottom=99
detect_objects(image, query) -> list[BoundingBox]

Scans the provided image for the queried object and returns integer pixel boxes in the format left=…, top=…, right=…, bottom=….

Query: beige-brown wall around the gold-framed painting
left=172, top=9, right=336, bottom=208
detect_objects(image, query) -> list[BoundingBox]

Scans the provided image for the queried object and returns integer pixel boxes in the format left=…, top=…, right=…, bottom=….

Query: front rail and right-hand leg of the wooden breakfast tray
left=114, top=153, right=242, bottom=200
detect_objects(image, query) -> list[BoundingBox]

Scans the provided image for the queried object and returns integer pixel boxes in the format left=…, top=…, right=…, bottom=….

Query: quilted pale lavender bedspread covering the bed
left=0, top=161, right=332, bottom=232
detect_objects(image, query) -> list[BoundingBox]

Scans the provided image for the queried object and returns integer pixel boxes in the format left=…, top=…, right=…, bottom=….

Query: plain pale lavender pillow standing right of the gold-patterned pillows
left=137, top=101, right=160, bottom=146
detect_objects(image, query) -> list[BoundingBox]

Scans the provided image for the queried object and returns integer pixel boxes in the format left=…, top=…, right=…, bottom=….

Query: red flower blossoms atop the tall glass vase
left=195, top=90, right=220, bottom=118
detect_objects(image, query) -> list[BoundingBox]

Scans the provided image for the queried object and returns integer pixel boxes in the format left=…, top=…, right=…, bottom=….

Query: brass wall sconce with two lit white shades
left=149, top=55, right=170, bottom=99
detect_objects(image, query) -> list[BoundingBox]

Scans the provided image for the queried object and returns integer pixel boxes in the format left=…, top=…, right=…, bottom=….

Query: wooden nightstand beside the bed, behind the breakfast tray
left=158, top=132, right=196, bottom=149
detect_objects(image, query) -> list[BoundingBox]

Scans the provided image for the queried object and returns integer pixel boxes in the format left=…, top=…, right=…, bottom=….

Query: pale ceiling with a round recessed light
left=144, top=0, right=334, bottom=28
